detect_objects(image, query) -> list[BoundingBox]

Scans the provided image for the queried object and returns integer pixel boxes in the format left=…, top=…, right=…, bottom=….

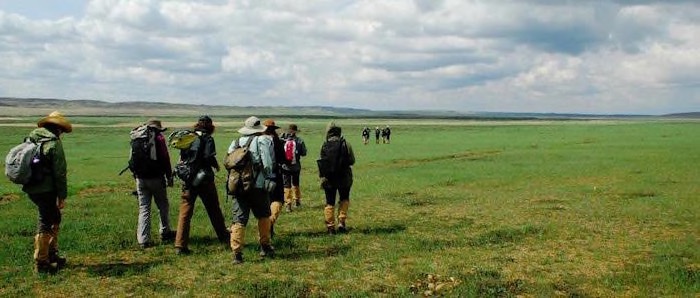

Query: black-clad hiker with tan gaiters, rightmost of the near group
left=317, top=122, right=355, bottom=235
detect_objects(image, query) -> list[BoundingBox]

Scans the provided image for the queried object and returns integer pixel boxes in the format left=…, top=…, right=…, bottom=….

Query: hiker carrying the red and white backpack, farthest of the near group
left=282, top=124, right=306, bottom=211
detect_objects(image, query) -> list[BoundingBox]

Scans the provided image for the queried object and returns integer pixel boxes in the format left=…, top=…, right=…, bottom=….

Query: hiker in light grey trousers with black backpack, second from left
left=129, top=119, right=175, bottom=249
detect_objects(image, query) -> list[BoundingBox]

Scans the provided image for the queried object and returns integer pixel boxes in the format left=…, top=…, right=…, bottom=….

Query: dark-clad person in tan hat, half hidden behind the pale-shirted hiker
left=263, top=119, right=287, bottom=237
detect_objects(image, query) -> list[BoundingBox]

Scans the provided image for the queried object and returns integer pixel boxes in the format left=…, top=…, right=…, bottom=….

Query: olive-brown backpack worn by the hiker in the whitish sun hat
left=224, top=136, right=258, bottom=196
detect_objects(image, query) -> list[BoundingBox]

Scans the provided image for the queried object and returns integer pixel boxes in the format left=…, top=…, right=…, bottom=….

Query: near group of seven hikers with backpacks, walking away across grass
left=5, top=112, right=355, bottom=273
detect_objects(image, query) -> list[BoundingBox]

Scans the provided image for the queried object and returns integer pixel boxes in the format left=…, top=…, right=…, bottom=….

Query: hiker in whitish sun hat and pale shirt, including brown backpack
left=225, top=116, right=277, bottom=265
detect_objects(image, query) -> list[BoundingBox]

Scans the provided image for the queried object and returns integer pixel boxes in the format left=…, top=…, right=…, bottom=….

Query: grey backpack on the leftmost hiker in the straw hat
left=5, top=138, right=55, bottom=185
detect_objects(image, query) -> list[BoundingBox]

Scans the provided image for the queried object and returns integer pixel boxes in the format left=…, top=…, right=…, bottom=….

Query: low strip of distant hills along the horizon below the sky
left=0, top=97, right=688, bottom=120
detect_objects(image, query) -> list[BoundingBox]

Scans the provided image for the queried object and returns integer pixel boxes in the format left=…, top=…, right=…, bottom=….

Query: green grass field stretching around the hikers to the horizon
left=0, top=117, right=700, bottom=297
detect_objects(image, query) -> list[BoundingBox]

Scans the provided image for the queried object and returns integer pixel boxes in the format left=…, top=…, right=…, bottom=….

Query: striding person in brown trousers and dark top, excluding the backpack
left=175, top=115, right=230, bottom=255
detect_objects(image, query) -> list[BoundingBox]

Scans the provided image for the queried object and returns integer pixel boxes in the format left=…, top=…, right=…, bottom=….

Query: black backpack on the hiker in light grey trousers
left=129, top=125, right=160, bottom=177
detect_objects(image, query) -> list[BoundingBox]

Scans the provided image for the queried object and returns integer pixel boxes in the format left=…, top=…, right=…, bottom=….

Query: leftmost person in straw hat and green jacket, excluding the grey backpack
left=22, top=111, right=73, bottom=273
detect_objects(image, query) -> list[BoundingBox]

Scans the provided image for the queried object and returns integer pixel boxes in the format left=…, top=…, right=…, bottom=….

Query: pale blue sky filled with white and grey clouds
left=0, top=0, right=700, bottom=114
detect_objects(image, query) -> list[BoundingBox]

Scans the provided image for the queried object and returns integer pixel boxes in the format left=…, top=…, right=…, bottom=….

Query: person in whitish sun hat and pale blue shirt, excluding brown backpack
left=228, top=116, right=276, bottom=265
